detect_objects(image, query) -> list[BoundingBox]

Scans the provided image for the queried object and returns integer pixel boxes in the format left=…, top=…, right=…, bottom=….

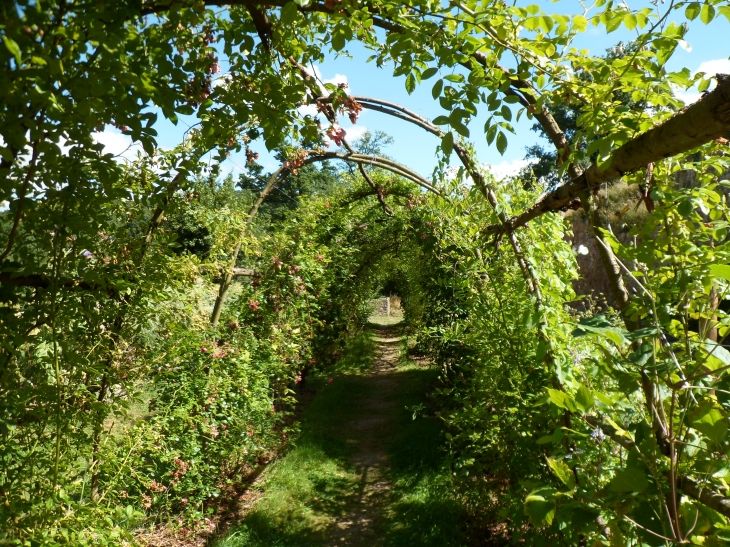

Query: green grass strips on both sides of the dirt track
left=217, top=326, right=466, bottom=547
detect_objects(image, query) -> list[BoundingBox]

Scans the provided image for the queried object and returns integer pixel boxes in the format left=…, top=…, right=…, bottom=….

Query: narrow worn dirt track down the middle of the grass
left=326, top=326, right=401, bottom=547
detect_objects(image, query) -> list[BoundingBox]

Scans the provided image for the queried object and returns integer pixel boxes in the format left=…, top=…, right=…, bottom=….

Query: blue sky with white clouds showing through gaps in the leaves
left=99, top=0, right=730, bottom=184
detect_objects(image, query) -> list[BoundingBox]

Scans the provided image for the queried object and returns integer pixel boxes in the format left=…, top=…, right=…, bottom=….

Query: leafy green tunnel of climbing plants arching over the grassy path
left=0, top=0, right=730, bottom=546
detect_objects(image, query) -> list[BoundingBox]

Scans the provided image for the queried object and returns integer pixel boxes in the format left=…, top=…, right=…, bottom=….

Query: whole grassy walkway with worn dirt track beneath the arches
left=217, top=324, right=466, bottom=547
